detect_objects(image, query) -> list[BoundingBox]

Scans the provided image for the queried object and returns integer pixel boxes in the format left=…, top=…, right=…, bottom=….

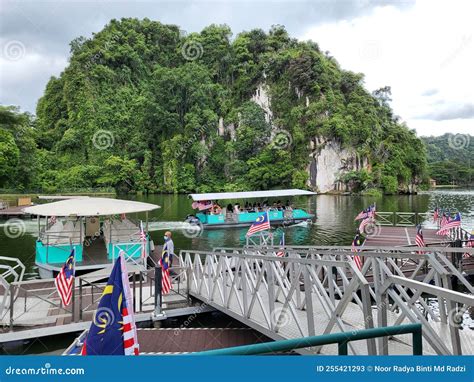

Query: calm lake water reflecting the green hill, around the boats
left=0, top=190, right=474, bottom=278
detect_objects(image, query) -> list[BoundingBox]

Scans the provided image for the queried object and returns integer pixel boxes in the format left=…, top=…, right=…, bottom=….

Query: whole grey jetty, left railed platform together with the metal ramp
left=0, top=242, right=474, bottom=354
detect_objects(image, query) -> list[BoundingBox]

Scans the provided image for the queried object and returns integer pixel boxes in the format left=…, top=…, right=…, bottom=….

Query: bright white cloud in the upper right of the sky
left=301, top=1, right=474, bottom=135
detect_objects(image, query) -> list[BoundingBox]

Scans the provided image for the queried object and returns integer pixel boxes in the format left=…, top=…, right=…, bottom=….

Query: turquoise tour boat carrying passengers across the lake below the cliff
left=186, top=189, right=316, bottom=228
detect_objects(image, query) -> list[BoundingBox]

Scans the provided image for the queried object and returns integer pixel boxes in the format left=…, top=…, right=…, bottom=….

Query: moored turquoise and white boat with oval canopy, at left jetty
left=24, top=197, right=160, bottom=278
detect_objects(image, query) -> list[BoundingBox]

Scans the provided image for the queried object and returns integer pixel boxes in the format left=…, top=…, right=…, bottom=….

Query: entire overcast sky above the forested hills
left=0, top=0, right=474, bottom=135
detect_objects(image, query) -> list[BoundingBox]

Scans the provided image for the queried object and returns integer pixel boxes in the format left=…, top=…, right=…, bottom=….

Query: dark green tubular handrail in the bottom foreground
left=193, top=324, right=423, bottom=355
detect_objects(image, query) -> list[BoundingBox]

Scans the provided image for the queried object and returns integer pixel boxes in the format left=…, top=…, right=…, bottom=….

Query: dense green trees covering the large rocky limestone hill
left=0, top=19, right=426, bottom=192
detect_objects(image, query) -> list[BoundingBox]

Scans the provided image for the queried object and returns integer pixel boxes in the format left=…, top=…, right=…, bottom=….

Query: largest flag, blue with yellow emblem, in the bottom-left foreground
left=81, top=256, right=138, bottom=355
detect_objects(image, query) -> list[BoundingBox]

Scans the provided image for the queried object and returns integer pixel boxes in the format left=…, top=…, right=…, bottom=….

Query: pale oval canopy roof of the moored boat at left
left=23, top=198, right=160, bottom=216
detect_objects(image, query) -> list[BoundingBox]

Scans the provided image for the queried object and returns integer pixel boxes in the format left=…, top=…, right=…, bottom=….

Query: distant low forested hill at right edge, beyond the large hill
left=423, top=134, right=474, bottom=185
